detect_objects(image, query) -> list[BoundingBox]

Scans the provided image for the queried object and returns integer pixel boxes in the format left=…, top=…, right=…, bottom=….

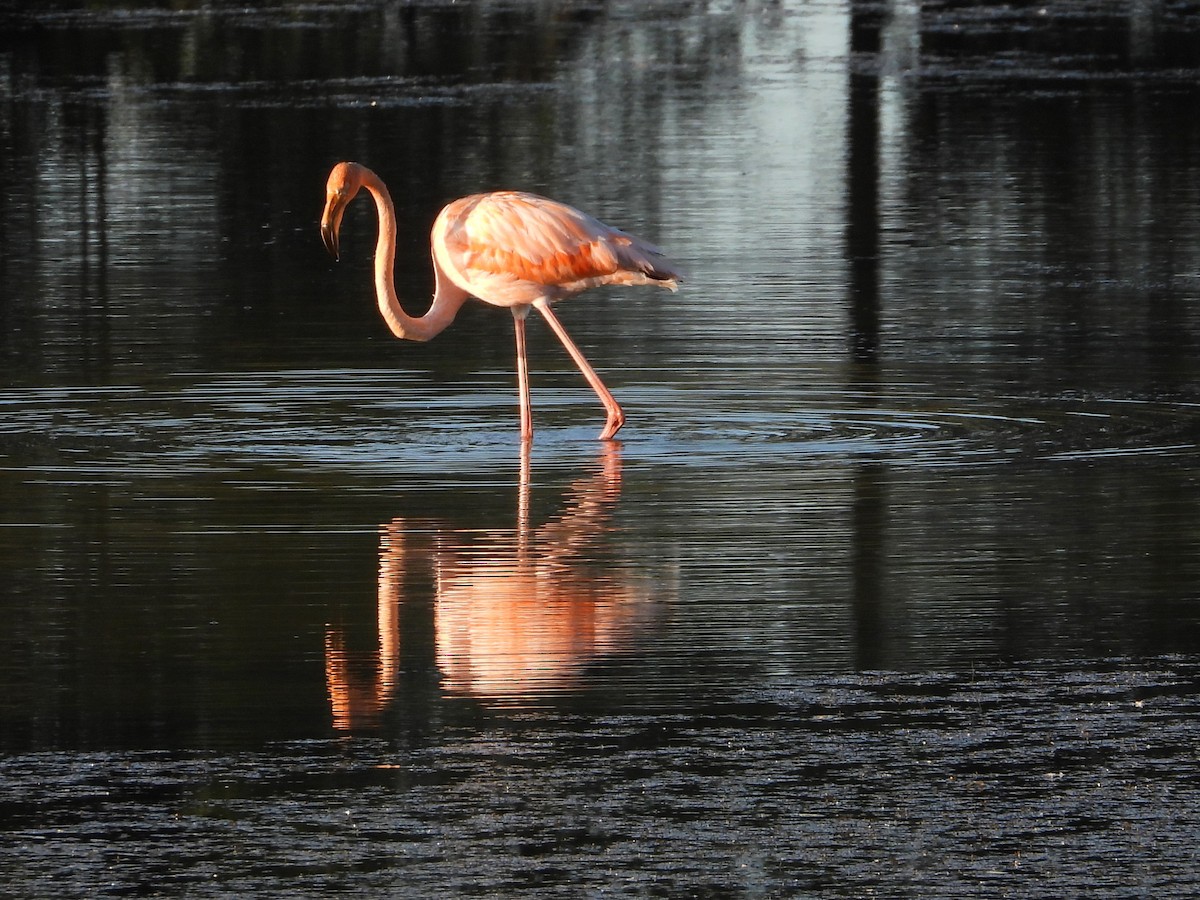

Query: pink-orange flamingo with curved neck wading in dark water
left=320, top=162, right=680, bottom=442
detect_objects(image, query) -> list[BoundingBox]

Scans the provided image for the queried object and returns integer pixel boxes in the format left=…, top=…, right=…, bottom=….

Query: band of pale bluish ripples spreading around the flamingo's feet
left=0, top=370, right=1200, bottom=480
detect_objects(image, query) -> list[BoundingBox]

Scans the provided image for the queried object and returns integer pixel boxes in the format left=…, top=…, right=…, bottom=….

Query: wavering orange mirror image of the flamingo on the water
left=325, top=444, right=658, bottom=730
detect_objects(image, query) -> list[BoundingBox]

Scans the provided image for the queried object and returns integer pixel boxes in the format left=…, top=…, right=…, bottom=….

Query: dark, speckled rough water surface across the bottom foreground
left=0, top=660, right=1200, bottom=898
